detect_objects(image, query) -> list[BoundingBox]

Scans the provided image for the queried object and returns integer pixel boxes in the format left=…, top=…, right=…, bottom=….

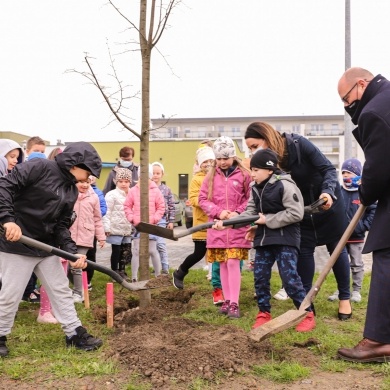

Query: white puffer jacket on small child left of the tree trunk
left=103, top=188, right=132, bottom=237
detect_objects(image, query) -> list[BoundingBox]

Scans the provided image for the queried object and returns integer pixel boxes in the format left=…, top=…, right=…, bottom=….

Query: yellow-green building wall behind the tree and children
left=92, top=140, right=244, bottom=200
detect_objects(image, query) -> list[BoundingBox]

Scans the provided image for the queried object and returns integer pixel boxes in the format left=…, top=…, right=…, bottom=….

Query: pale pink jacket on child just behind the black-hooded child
left=69, top=189, right=106, bottom=248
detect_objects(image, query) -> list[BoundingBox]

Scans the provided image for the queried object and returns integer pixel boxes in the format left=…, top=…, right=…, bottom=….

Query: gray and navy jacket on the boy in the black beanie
left=241, top=174, right=304, bottom=249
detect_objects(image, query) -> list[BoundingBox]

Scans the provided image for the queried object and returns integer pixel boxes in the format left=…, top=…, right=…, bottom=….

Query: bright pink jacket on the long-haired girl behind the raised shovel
left=199, top=167, right=251, bottom=248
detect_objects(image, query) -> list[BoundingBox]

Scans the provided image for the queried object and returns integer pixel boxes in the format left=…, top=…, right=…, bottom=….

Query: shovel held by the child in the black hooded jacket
left=0, top=227, right=172, bottom=291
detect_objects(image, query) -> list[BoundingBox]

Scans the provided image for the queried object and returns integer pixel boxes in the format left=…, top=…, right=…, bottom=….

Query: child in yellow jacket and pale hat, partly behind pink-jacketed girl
left=173, top=146, right=216, bottom=292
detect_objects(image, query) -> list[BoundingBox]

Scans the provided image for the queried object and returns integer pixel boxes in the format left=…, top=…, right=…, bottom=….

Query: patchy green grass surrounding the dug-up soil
left=0, top=270, right=390, bottom=390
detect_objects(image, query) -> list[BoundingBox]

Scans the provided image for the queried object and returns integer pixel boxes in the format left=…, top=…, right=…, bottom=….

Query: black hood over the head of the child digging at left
left=55, top=142, right=102, bottom=178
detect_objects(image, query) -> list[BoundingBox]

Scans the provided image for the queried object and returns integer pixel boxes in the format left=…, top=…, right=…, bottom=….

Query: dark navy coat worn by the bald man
left=352, top=74, right=390, bottom=253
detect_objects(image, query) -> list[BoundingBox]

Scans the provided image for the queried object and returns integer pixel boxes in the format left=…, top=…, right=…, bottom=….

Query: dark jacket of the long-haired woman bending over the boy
left=283, top=134, right=347, bottom=247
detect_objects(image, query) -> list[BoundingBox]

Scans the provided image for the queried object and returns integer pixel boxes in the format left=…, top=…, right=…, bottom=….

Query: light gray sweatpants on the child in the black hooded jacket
left=0, top=252, right=81, bottom=337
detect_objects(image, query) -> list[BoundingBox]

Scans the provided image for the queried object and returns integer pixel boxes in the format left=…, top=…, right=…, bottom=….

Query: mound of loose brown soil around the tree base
left=95, top=290, right=320, bottom=388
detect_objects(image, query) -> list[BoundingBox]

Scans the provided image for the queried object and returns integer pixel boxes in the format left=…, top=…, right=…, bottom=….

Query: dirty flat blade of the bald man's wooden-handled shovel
left=249, top=310, right=307, bottom=341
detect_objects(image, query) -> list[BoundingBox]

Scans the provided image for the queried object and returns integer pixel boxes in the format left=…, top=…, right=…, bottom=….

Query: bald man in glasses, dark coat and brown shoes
left=338, top=68, right=390, bottom=363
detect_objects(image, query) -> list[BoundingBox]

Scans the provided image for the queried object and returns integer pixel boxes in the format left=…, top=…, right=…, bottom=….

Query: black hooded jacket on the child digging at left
left=0, top=142, right=101, bottom=257
